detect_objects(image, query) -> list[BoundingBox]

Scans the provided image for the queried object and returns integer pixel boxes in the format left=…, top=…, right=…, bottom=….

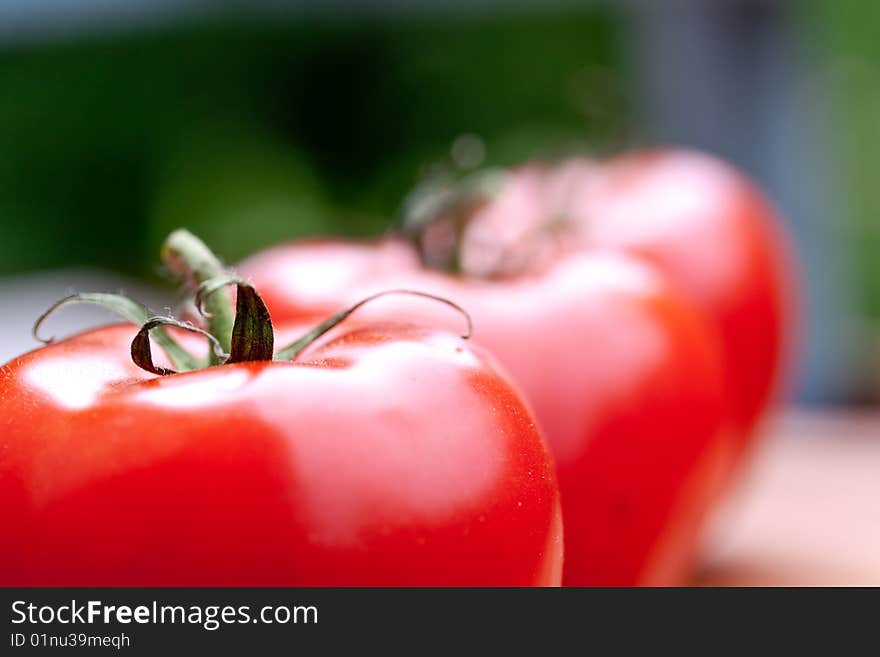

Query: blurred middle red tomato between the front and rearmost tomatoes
left=241, top=241, right=730, bottom=585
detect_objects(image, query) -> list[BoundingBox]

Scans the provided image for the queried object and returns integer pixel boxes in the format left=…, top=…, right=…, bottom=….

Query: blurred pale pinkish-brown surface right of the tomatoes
left=694, top=411, right=880, bottom=586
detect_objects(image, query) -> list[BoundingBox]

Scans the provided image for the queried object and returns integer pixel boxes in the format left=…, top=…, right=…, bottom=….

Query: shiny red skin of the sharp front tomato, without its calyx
left=0, top=324, right=562, bottom=586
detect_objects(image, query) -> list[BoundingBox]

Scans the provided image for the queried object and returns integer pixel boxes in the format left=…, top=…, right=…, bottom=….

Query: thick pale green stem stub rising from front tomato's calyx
left=162, top=228, right=235, bottom=365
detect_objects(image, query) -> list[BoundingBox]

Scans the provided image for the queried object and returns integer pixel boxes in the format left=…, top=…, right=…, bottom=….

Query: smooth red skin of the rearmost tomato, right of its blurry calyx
left=543, top=149, right=797, bottom=444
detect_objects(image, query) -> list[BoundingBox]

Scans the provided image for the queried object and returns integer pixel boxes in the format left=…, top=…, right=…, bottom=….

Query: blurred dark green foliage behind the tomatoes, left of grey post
left=0, top=11, right=624, bottom=274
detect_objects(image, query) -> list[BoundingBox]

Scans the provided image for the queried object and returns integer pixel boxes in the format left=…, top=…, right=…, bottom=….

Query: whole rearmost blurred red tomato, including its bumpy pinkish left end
left=458, top=150, right=796, bottom=452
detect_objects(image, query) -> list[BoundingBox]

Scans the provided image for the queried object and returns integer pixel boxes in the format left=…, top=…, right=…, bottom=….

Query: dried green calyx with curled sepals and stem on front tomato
left=33, top=229, right=473, bottom=376
